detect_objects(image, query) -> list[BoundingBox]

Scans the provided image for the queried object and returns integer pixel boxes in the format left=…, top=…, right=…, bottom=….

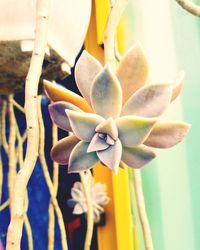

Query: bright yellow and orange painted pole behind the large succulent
left=85, top=0, right=134, bottom=250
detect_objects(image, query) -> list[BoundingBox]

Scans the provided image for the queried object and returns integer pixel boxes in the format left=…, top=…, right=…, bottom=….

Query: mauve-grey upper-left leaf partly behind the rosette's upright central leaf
left=75, top=50, right=103, bottom=104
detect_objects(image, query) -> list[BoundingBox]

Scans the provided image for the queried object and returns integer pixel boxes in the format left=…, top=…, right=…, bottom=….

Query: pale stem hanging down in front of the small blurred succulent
left=80, top=170, right=94, bottom=250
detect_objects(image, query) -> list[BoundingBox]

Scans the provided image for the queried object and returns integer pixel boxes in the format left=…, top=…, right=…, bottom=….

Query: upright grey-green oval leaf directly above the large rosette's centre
left=90, top=65, right=122, bottom=118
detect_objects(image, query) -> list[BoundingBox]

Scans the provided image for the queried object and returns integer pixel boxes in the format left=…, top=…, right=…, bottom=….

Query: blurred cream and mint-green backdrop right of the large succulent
left=124, top=0, right=200, bottom=250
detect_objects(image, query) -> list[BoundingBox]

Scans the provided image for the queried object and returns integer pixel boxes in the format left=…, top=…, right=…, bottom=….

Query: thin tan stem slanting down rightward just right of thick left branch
left=38, top=96, right=68, bottom=250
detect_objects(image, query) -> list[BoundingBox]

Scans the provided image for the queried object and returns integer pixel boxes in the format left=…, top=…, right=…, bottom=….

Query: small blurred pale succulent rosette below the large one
left=67, top=179, right=109, bottom=222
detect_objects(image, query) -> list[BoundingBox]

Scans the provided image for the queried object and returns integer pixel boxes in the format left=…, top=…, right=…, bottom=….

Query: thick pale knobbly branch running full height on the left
left=6, top=0, right=50, bottom=250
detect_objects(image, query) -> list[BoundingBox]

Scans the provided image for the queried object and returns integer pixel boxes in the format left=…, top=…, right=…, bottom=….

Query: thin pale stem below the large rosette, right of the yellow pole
left=133, top=169, right=153, bottom=250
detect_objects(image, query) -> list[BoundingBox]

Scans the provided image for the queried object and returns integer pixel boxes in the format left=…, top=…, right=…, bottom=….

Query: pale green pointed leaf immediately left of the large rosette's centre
left=65, top=109, right=104, bottom=142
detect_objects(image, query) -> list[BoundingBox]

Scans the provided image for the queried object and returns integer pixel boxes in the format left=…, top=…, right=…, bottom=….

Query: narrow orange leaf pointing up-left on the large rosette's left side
left=43, top=80, right=92, bottom=112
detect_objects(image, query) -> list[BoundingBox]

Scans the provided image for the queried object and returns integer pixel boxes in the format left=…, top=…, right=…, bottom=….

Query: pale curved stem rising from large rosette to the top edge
left=104, top=0, right=128, bottom=69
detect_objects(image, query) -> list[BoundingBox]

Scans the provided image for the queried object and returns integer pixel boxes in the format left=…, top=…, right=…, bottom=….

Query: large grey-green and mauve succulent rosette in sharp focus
left=44, top=44, right=189, bottom=174
